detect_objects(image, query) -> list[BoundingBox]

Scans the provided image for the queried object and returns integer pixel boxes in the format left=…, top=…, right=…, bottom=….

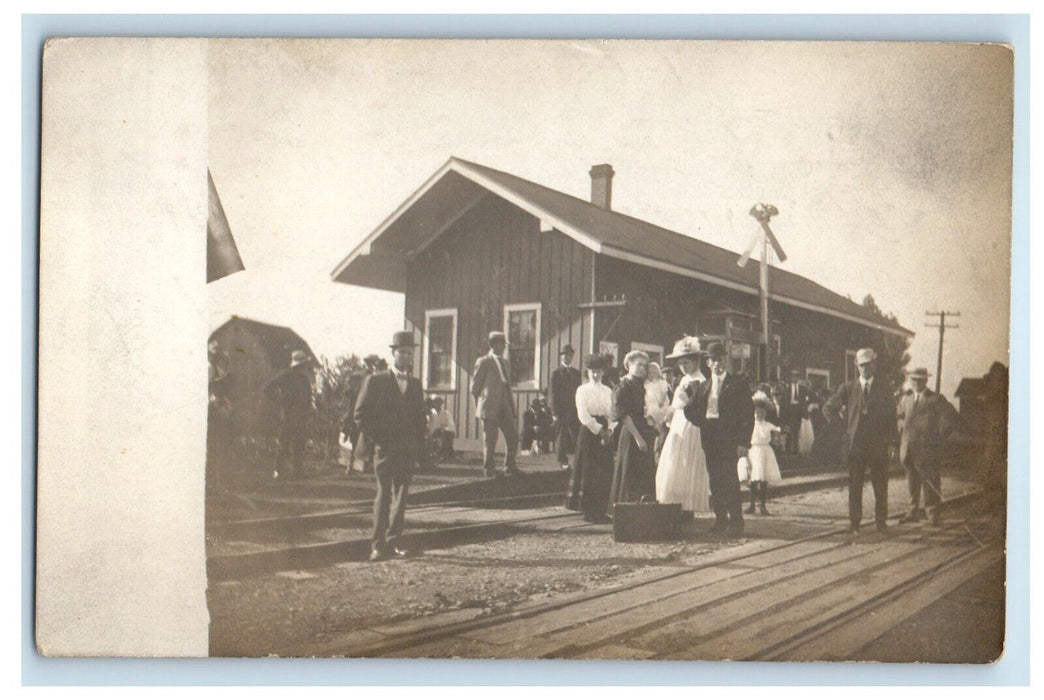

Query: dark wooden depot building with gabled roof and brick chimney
left=332, top=158, right=914, bottom=446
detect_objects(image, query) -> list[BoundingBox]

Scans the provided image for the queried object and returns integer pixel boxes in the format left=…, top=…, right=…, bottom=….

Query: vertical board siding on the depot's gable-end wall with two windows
left=406, top=194, right=593, bottom=448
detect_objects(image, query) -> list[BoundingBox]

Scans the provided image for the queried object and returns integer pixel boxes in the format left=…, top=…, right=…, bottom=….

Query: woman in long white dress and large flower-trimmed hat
left=656, top=335, right=711, bottom=513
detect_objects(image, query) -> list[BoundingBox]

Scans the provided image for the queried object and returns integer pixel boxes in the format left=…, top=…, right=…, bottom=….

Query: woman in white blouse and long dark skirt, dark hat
left=566, top=355, right=616, bottom=522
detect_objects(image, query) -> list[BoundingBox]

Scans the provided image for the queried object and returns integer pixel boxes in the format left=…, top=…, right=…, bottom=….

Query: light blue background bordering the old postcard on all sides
left=22, top=15, right=1029, bottom=685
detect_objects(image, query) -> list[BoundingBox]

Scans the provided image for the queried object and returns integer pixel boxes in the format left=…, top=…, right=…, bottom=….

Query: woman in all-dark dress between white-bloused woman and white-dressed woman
left=609, top=350, right=656, bottom=514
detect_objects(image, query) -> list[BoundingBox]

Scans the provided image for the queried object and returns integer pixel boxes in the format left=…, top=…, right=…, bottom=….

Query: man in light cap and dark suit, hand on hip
left=823, top=348, right=898, bottom=534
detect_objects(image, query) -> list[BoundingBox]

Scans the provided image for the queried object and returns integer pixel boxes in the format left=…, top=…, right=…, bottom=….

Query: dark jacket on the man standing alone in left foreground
left=355, top=370, right=427, bottom=462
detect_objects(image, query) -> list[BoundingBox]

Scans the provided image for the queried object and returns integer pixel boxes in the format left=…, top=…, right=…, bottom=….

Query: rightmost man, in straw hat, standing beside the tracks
left=897, top=367, right=957, bottom=526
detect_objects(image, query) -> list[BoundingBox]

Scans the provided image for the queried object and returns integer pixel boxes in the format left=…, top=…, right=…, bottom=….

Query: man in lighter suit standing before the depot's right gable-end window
left=471, top=330, right=519, bottom=476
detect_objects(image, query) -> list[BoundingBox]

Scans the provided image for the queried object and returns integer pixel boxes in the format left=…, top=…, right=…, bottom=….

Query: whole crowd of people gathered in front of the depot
left=211, top=331, right=957, bottom=560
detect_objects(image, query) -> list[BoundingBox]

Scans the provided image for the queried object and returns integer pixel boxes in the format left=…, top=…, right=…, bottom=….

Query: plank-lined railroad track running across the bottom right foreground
left=286, top=492, right=1003, bottom=660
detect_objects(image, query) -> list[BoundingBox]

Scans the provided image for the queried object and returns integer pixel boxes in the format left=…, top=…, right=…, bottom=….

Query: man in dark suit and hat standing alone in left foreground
left=355, top=330, right=427, bottom=561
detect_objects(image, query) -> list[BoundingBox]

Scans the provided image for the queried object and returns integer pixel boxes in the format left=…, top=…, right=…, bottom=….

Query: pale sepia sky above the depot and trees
left=208, top=40, right=1013, bottom=396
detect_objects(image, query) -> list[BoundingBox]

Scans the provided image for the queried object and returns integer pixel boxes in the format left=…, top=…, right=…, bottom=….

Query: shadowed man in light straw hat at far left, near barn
left=264, top=350, right=314, bottom=479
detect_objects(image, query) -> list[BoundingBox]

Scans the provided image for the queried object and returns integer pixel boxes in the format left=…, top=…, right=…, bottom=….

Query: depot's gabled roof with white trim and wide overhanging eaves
left=332, top=158, right=914, bottom=336
